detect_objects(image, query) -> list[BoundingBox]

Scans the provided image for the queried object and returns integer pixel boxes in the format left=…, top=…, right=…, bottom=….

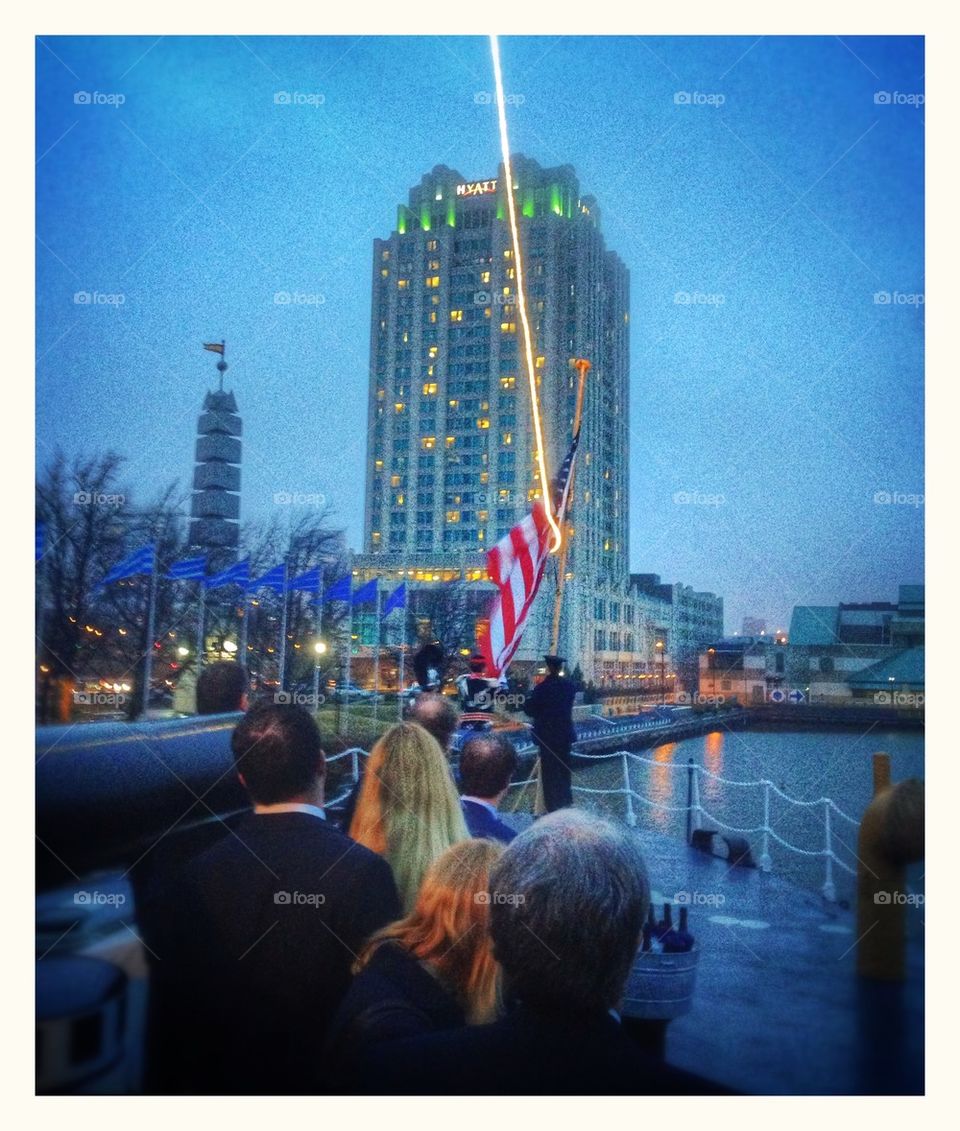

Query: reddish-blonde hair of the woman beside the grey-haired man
left=354, top=840, right=503, bottom=1025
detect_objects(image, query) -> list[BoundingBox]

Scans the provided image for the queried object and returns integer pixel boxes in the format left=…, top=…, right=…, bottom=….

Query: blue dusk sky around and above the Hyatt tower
left=36, top=36, right=925, bottom=632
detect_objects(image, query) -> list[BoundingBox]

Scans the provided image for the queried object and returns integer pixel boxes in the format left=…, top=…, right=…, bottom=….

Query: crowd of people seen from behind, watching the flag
left=141, top=665, right=724, bottom=1095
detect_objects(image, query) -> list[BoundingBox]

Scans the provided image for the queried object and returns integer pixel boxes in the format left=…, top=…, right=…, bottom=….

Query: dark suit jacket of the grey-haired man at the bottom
left=361, top=1005, right=728, bottom=1096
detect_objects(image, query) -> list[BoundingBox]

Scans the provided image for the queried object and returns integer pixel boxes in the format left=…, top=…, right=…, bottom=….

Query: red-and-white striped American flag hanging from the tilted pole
left=481, top=429, right=580, bottom=675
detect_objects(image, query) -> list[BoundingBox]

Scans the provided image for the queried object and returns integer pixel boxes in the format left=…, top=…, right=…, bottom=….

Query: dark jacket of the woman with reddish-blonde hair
left=325, top=942, right=465, bottom=1094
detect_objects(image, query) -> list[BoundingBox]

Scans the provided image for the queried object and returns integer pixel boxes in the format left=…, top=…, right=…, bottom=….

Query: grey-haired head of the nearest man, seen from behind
left=490, top=809, right=650, bottom=1012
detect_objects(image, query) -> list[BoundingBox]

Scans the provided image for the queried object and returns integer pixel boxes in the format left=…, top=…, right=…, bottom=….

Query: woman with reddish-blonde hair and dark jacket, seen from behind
left=328, top=839, right=503, bottom=1081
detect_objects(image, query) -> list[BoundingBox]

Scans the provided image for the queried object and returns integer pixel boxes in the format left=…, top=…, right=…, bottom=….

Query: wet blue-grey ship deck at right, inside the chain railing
left=508, top=814, right=924, bottom=1095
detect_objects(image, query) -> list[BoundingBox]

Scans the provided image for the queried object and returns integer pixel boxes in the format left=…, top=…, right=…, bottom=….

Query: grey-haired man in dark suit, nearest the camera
left=361, top=810, right=727, bottom=1096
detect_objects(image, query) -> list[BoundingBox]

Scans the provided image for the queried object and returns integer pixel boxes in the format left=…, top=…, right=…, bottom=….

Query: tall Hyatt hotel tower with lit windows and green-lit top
left=365, top=157, right=629, bottom=665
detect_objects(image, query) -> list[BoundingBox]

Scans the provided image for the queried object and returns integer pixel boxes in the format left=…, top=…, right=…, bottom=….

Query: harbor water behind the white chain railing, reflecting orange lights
left=574, top=727, right=924, bottom=900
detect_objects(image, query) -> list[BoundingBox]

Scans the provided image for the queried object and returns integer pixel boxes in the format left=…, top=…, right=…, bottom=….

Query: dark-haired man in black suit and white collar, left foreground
left=156, top=703, right=400, bottom=1094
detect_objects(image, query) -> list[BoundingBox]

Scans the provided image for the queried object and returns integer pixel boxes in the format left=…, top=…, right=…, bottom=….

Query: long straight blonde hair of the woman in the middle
left=349, top=723, right=469, bottom=912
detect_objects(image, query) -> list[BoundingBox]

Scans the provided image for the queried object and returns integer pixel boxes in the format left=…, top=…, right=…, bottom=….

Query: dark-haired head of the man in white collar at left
left=231, top=703, right=326, bottom=805
